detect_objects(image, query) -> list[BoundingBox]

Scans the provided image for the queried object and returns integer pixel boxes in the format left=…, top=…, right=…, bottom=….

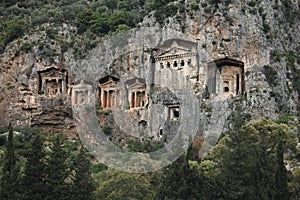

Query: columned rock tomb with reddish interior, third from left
left=98, top=76, right=120, bottom=109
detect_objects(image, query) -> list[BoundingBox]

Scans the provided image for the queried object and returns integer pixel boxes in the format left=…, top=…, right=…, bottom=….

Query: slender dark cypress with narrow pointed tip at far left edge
left=0, top=125, right=20, bottom=200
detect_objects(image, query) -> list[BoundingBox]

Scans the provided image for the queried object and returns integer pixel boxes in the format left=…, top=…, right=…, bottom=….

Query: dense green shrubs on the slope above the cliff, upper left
left=0, top=0, right=183, bottom=52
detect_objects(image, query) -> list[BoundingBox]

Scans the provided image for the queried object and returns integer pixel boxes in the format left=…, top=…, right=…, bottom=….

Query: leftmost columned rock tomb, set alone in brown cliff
left=38, top=68, right=68, bottom=97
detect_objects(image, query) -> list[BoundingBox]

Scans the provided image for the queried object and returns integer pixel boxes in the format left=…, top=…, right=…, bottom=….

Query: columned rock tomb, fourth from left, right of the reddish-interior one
left=126, top=78, right=147, bottom=108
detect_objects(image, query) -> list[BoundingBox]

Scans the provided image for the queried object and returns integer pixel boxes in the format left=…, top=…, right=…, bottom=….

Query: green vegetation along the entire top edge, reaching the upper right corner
left=0, top=0, right=300, bottom=57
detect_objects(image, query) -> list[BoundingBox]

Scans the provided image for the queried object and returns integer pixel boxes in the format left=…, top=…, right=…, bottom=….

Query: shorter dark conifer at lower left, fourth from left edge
left=72, top=147, right=95, bottom=200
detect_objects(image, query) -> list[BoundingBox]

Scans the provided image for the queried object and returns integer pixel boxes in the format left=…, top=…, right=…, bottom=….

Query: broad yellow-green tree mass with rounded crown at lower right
left=203, top=119, right=289, bottom=199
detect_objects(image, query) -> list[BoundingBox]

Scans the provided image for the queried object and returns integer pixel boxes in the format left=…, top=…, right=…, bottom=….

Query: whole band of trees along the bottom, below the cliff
left=0, top=114, right=300, bottom=200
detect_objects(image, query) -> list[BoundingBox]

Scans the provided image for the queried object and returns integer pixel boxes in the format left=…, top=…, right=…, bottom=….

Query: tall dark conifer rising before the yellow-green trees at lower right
left=212, top=106, right=250, bottom=199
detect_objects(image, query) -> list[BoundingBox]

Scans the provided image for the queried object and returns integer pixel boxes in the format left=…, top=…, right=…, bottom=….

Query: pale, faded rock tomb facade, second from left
left=71, top=80, right=93, bottom=105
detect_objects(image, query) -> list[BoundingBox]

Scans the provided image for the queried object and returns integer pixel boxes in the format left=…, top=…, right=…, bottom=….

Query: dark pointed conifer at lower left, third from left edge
left=46, top=136, right=71, bottom=200
